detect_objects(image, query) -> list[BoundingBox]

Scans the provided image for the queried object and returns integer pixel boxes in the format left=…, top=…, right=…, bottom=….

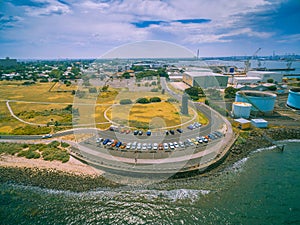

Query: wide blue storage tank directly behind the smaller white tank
left=235, top=91, right=277, bottom=114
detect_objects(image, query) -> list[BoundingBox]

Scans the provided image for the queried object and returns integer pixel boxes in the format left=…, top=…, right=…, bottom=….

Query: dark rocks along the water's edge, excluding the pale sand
left=0, top=128, right=300, bottom=192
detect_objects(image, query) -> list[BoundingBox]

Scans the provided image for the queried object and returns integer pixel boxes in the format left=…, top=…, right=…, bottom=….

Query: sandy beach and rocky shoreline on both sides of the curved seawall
left=0, top=128, right=300, bottom=191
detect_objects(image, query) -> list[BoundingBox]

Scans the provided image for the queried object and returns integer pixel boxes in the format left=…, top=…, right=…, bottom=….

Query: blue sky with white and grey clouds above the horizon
left=0, top=0, right=300, bottom=59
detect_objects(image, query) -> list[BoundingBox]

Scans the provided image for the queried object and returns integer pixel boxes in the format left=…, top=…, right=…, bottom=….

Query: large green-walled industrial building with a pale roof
left=182, top=71, right=228, bottom=89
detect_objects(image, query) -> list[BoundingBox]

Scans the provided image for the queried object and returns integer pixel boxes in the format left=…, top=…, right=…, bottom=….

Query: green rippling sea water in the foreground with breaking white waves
left=0, top=140, right=300, bottom=225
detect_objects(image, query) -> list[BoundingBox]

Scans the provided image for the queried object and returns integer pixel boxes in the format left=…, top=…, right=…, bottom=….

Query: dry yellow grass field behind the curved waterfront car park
left=0, top=81, right=208, bottom=134
